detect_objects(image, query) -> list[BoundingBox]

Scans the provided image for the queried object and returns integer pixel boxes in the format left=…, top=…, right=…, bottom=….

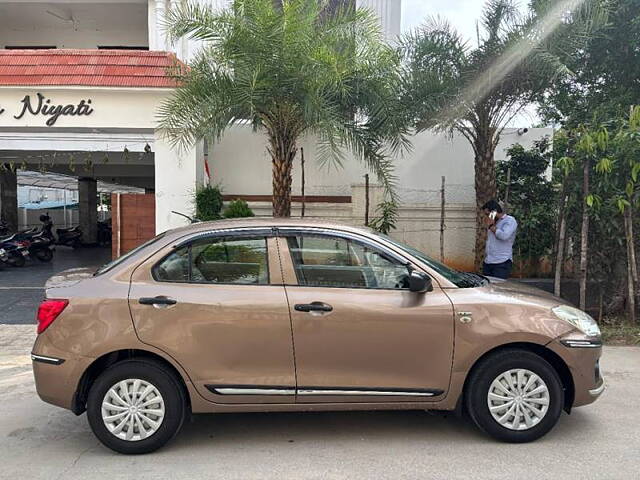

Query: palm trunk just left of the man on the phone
left=474, top=134, right=496, bottom=271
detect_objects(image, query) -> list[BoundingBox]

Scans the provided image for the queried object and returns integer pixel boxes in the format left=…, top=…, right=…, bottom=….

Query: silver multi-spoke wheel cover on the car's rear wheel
left=102, top=378, right=165, bottom=442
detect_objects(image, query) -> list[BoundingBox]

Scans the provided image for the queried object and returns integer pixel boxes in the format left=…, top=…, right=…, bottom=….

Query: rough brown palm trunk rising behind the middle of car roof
left=265, top=112, right=299, bottom=217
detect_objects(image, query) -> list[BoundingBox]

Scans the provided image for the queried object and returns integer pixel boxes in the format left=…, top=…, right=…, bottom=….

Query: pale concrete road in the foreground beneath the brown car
left=0, top=325, right=640, bottom=480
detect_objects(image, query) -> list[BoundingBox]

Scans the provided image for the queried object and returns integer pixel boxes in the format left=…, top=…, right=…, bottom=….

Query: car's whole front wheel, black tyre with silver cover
left=465, top=349, right=564, bottom=443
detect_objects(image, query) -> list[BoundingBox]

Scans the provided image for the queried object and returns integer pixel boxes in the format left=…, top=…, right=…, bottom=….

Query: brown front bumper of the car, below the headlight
left=547, top=331, right=606, bottom=407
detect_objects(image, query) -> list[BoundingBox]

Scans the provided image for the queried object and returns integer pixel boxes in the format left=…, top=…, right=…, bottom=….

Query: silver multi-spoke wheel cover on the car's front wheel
left=487, top=368, right=550, bottom=430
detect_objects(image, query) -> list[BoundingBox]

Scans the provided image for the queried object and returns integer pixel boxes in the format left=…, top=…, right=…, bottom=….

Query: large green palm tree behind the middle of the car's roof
left=160, top=0, right=408, bottom=217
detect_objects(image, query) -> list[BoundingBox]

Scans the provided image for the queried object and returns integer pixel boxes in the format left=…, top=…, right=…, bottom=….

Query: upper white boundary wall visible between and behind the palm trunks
left=209, top=126, right=552, bottom=204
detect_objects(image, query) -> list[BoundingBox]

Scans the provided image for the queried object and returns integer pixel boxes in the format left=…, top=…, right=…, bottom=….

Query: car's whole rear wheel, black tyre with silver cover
left=87, top=359, right=187, bottom=455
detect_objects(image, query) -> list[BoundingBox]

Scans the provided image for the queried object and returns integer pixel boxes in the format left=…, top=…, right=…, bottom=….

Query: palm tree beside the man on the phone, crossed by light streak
left=400, top=0, right=606, bottom=267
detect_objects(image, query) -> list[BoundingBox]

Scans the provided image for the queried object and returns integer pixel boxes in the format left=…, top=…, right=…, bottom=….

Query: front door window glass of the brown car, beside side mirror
left=287, top=235, right=409, bottom=289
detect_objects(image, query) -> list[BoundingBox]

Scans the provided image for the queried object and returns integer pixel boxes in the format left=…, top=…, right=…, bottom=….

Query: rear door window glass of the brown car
left=154, top=237, right=269, bottom=285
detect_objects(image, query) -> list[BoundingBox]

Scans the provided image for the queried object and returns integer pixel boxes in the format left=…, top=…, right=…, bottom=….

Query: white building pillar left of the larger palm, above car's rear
left=154, top=132, right=204, bottom=233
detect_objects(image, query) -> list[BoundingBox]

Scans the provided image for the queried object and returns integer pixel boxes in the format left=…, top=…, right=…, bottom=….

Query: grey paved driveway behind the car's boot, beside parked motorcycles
left=0, top=247, right=111, bottom=324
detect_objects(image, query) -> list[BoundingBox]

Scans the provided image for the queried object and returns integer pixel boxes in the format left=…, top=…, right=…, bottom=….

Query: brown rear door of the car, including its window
left=129, top=230, right=295, bottom=403
